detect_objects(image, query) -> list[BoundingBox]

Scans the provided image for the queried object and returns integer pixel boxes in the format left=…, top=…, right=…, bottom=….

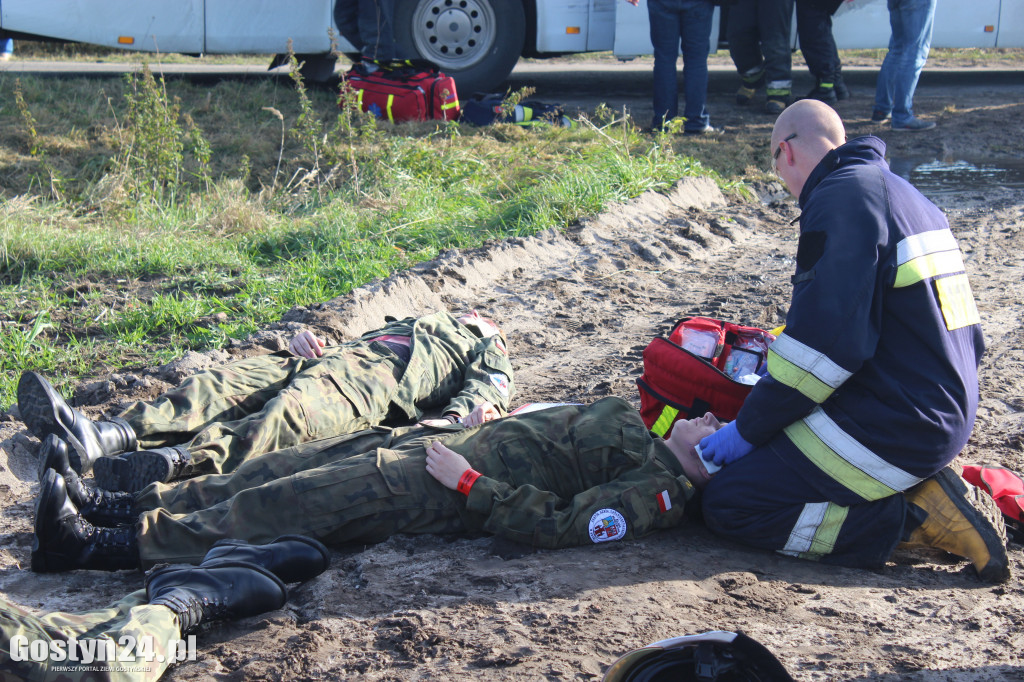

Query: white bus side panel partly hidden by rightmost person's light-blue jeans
left=833, top=0, right=995, bottom=49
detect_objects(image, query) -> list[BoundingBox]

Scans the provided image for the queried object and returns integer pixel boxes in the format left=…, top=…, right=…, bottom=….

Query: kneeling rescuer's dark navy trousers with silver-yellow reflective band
left=702, top=444, right=907, bottom=568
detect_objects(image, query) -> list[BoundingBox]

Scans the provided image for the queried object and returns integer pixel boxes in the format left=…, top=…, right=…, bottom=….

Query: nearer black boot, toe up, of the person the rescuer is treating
left=32, top=469, right=139, bottom=573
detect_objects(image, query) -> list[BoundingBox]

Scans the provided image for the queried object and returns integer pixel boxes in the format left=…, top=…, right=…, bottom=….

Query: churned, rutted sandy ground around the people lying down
left=0, top=61, right=1024, bottom=681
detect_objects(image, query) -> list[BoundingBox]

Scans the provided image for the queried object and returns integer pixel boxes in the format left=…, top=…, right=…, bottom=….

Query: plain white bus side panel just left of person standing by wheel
left=205, top=0, right=338, bottom=54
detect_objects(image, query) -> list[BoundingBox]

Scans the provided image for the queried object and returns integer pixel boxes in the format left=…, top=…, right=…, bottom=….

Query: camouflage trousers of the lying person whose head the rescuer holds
left=136, top=427, right=466, bottom=568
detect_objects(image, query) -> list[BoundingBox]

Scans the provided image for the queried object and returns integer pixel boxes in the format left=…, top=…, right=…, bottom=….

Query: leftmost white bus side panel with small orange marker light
left=0, top=0, right=203, bottom=53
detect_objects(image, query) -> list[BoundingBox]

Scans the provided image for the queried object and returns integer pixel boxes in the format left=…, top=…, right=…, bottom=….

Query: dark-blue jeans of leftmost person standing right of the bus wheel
left=647, top=0, right=715, bottom=131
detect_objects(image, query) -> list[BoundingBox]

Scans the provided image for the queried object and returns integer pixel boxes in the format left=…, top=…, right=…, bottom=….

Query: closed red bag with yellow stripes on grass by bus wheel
left=339, top=61, right=460, bottom=123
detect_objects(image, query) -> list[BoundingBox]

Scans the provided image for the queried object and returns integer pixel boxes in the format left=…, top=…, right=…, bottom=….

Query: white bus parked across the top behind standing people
left=0, top=0, right=1024, bottom=92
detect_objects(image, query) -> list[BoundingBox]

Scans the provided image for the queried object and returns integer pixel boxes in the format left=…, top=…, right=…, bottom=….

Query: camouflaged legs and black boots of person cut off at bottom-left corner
left=0, top=537, right=329, bottom=682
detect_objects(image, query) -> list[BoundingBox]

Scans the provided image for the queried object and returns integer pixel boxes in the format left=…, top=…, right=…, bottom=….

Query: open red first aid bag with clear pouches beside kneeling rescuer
left=637, top=317, right=775, bottom=437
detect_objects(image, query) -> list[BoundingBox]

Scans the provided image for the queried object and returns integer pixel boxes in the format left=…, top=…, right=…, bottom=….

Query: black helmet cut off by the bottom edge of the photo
left=603, top=630, right=793, bottom=682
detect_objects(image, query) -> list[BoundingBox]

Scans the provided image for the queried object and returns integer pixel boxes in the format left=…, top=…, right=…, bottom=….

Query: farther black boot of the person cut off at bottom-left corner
left=199, top=536, right=331, bottom=583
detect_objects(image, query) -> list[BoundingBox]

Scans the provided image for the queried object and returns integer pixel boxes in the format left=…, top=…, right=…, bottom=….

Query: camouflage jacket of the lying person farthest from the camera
left=360, top=312, right=515, bottom=420
